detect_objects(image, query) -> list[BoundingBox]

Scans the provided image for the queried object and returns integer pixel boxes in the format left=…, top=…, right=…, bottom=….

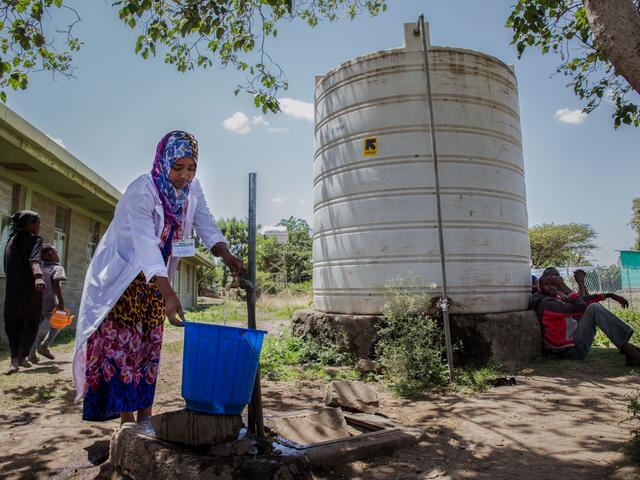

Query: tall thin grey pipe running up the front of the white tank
left=413, top=13, right=453, bottom=382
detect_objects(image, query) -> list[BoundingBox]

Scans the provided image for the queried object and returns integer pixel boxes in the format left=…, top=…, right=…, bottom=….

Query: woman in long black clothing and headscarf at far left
left=4, top=210, right=45, bottom=374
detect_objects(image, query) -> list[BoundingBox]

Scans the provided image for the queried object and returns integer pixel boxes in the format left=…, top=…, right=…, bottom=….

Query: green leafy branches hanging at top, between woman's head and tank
left=114, top=0, right=387, bottom=113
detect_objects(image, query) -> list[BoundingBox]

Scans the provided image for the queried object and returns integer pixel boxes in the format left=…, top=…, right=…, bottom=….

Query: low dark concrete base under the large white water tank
left=293, top=310, right=542, bottom=365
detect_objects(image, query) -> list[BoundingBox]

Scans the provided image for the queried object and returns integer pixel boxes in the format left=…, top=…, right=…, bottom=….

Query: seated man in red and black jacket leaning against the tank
left=531, top=275, right=640, bottom=366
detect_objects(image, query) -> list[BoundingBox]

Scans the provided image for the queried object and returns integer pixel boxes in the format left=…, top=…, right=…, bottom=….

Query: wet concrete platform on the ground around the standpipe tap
left=104, top=412, right=423, bottom=480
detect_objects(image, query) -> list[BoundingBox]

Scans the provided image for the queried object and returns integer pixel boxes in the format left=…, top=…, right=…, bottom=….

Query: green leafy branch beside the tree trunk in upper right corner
left=506, top=0, right=640, bottom=128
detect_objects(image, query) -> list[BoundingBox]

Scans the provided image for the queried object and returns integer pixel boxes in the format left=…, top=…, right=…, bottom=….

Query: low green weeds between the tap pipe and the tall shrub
left=260, top=330, right=358, bottom=381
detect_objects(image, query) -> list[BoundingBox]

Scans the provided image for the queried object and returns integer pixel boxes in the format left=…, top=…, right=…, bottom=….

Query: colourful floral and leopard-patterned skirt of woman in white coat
left=82, top=273, right=164, bottom=421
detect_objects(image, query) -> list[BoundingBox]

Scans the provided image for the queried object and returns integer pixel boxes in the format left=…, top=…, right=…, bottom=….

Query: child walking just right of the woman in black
left=29, top=245, right=67, bottom=363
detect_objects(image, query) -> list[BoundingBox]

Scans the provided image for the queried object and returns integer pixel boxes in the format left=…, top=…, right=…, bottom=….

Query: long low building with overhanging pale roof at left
left=0, top=105, right=214, bottom=336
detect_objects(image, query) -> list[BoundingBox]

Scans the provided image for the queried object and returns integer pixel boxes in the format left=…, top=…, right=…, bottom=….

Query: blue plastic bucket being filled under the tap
left=182, top=321, right=267, bottom=415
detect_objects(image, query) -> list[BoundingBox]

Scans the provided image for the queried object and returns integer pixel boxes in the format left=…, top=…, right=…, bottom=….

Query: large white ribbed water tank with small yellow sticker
left=313, top=24, right=530, bottom=314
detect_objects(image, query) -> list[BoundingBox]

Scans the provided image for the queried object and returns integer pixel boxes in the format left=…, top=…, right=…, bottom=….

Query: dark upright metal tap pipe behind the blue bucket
left=244, top=173, right=264, bottom=438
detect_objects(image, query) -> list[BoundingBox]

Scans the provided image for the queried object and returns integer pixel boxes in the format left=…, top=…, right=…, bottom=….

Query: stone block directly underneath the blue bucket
left=151, top=409, right=244, bottom=446
